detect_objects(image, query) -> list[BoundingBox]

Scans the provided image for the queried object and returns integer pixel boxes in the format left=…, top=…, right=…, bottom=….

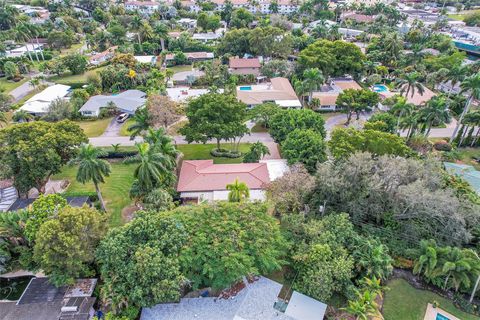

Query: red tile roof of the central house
left=177, top=160, right=270, bottom=192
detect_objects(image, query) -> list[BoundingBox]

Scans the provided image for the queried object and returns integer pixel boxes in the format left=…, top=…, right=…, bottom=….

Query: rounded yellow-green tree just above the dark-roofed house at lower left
left=34, top=207, right=107, bottom=286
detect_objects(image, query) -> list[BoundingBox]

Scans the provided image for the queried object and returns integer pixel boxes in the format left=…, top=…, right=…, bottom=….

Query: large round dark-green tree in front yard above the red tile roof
left=180, top=92, right=248, bottom=149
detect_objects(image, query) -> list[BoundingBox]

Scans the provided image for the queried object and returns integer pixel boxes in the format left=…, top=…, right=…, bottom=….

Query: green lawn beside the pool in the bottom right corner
left=383, top=279, right=479, bottom=320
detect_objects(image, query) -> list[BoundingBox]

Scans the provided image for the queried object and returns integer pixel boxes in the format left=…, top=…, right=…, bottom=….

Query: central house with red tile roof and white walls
left=177, top=159, right=288, bottom=203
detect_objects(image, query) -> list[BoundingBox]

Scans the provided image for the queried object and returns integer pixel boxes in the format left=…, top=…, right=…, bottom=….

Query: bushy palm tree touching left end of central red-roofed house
left=124, top=142, right=175, bottom=194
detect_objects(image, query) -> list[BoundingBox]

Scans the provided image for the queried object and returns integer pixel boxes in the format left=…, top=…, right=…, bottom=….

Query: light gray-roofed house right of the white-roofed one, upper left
left=78, top=90, right=147, bottom=117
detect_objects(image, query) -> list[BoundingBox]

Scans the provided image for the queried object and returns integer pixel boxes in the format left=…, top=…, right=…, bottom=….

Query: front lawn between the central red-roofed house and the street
left=177, top=143, right=250, bottom=163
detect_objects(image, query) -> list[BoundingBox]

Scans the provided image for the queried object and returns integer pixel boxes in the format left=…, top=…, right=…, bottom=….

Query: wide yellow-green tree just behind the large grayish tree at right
left=328, top=128, right=410, bottom=159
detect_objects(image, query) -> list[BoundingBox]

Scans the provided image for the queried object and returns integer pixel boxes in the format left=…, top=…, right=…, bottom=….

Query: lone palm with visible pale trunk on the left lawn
left=70, top=144, right=111, bottom=211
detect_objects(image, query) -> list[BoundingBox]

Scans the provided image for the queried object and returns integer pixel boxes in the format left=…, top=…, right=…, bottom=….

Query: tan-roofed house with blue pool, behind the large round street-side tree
left=237, top=77, right=302, bottom=108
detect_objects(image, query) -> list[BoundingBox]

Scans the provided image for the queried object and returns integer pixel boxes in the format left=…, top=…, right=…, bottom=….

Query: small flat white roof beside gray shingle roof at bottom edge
left=285, top=291, right=327, bottom=320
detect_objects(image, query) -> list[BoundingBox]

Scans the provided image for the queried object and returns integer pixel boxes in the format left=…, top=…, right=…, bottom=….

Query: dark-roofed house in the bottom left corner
left=0, top=278, right=97, bottom=320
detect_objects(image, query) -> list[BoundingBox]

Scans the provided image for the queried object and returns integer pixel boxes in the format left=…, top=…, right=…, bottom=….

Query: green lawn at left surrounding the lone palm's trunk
left=52, top=162, right=137, bottom=227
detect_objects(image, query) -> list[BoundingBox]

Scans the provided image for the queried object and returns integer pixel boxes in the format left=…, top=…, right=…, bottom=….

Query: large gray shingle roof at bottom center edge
left=140, top=277, right=324, bottom=320
